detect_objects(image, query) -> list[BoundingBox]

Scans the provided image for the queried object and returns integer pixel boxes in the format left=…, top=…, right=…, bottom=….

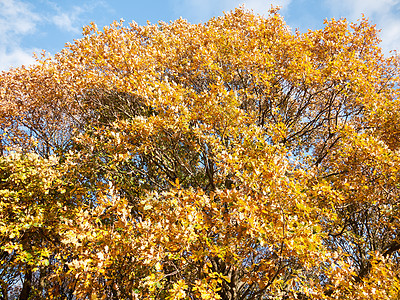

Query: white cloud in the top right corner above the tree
left=325, top=0, right=400, bottom=52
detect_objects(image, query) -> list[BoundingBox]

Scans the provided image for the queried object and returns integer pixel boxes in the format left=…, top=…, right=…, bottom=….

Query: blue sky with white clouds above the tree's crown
left=0, top=0, right=400, bottom=70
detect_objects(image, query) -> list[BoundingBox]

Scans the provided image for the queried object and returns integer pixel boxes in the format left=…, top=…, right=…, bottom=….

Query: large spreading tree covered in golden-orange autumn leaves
left=0, top=9, right=400, bottom=300
